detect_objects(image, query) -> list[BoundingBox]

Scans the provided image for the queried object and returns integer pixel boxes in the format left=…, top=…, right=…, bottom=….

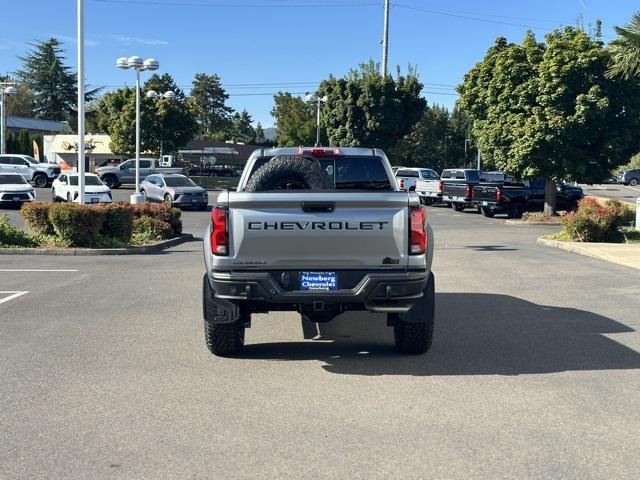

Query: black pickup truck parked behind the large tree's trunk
left=473, top=179, right=584, bottom=218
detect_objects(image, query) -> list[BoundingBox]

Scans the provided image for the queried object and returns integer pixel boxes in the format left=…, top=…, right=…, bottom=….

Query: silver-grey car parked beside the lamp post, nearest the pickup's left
left=140, top=173, right=209, bottom=210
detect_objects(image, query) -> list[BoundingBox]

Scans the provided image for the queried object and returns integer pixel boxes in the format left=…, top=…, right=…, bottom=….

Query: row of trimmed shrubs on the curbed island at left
left=21, top=202, right=182, bottom=248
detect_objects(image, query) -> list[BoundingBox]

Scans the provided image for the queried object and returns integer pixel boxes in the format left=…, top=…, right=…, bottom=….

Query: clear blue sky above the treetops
left=0, top=0, right=640, bottom=127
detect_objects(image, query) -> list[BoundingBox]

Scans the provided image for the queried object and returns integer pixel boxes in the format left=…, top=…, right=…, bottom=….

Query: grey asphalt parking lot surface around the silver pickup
left=0, top=195, right=640, bottom=479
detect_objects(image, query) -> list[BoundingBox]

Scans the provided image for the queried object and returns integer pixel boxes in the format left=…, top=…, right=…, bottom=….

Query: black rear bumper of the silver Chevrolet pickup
left=208, top=270, right=429, bottom=313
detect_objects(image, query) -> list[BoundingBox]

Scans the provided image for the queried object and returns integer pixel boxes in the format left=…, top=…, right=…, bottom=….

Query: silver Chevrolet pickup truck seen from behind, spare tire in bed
left=203, top=147, right=435, bottom=356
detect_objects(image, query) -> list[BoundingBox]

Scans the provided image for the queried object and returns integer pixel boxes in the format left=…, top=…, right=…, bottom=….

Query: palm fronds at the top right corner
left=607, top=12, right=640, bottom=79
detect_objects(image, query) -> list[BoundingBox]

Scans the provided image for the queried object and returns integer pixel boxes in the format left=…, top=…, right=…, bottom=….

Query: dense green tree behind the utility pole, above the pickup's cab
left=318, top=61, right=426, bottom=149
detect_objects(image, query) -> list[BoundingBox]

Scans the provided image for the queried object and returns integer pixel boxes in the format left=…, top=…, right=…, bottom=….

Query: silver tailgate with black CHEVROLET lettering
left=222, top=191, right=409, bottom=271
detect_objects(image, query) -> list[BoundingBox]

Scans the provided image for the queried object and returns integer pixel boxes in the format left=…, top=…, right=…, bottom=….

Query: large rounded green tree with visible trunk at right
left=458, top=27, right=640, bottom=214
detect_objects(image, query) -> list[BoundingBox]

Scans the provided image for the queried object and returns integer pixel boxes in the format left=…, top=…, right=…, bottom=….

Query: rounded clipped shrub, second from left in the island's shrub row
left=49, top=203, right=105, bottom=247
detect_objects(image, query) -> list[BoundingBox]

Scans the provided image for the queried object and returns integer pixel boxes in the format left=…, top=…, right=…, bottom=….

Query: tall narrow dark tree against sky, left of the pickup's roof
left=189, top=73, right=233, bottom=136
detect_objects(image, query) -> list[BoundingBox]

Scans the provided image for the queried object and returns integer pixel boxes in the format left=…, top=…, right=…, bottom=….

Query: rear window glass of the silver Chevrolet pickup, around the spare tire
left=249, top=156, right=392, bottom=191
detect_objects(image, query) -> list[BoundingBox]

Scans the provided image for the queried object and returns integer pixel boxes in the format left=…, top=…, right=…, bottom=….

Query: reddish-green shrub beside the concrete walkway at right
left=562, top=197, right=626, bottom=242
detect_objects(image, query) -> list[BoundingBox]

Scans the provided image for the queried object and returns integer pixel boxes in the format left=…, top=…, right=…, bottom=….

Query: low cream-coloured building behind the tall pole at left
left=43, top=134, right=126, bottom=171
